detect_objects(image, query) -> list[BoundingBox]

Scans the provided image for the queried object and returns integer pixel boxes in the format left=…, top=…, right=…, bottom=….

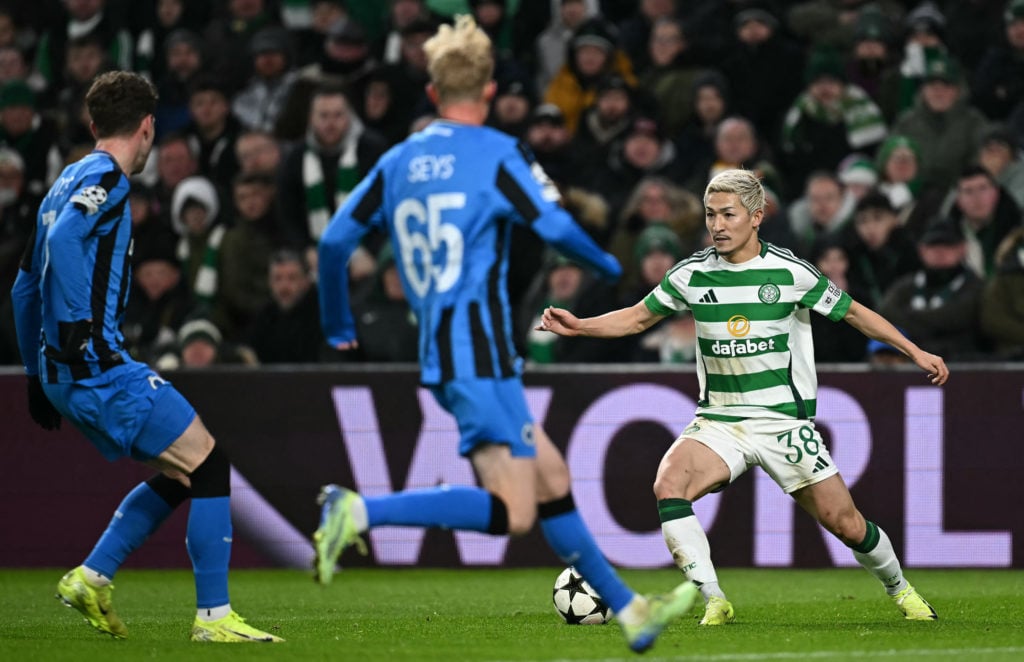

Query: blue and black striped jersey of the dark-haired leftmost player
left=11, top=151, right=131, bottom=383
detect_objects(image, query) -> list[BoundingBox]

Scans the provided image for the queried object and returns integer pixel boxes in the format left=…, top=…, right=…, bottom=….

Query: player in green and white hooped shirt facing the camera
left=538, top=170, right=949, bottom=625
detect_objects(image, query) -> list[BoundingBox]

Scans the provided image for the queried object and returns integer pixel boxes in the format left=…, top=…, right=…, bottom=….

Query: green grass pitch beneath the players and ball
left=0, top=568, right=1024, bottom=662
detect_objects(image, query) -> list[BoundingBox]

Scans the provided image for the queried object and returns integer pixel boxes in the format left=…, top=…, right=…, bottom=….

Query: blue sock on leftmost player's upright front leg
left=185, top=496, right=231, bottom=609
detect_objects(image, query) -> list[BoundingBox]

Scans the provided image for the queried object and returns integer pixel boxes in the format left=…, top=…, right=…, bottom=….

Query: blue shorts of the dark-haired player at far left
left=43, top=361, right=196, bottom=461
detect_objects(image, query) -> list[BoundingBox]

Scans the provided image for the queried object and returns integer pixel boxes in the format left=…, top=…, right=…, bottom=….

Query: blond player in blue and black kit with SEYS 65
left=313, top=16, right=697, bottom=652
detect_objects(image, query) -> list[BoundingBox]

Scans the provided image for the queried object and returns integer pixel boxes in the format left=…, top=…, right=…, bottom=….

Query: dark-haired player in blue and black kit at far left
left=11, top=72, right=283, bottom=642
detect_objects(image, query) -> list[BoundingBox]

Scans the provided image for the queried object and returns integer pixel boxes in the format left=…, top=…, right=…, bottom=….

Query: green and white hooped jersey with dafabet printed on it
left=644, top=242, right=853, bottom=421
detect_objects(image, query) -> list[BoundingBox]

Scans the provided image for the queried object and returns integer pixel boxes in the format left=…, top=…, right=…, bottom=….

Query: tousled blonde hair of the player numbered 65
left=423, top=15, right=495, bottom=105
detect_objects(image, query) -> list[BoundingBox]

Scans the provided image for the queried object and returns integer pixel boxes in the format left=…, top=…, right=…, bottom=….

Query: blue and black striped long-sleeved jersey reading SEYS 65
left=319, top=121, right=622, bottom=384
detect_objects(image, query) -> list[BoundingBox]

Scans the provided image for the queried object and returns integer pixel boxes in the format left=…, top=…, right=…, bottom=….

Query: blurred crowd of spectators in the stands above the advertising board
left=0, top=0, right=1024, bottom=368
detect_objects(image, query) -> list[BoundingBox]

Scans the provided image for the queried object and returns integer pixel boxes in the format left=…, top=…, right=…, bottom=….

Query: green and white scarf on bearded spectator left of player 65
left=302, top=121, right=362, bottom=241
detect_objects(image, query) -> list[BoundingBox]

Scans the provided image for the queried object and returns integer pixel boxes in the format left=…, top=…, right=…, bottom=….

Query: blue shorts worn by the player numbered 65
left=430, top=377, right=537, bottom=457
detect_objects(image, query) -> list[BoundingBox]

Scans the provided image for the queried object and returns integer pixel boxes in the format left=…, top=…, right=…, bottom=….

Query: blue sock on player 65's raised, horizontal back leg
left=364, top=485, right=497, bottom=533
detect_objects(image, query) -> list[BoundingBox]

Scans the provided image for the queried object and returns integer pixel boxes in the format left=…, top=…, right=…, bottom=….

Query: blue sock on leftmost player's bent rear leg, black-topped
left=84, top=483, right=173, bottom=579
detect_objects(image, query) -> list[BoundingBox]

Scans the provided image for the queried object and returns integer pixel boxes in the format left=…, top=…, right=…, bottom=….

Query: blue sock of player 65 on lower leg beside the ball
left=538, top=494, right=635, bottom=613
